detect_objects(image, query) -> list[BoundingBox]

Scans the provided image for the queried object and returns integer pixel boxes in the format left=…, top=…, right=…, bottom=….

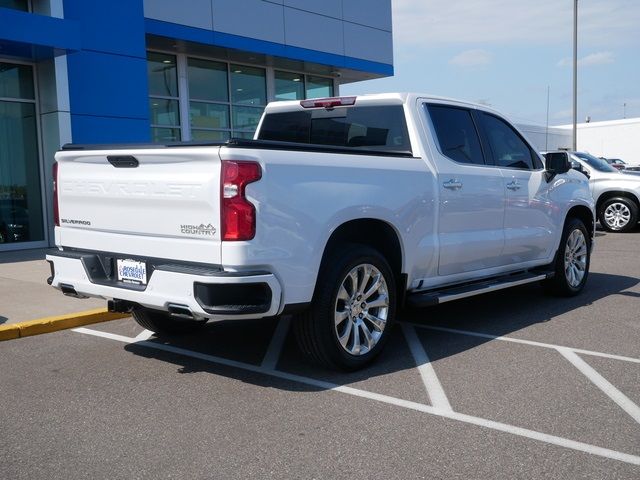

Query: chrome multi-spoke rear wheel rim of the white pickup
left=334, top=263, right=389, bottom=356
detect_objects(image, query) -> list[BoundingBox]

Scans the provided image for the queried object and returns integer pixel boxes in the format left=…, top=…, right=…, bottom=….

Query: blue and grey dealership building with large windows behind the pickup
left=0, top=0, right=393, bottom=252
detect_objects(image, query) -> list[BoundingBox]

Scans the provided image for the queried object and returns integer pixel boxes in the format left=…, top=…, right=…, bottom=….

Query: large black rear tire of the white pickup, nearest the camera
left=293, top=244, right=396, bottom=371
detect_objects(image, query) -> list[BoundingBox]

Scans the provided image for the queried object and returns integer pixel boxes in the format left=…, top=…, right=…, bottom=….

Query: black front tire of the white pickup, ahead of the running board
left=543, top=217, right=591, bottom=297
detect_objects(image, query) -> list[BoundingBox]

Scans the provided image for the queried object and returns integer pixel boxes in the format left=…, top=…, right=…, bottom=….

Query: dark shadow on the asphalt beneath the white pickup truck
left=125, top=273, right=640, bottom=396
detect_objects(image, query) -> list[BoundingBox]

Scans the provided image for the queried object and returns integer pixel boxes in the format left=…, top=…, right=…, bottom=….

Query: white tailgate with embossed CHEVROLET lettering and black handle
left=56, top=147, right=221, bottom=264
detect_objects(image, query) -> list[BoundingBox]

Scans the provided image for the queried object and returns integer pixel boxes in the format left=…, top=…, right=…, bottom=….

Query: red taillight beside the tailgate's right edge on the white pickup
left=220, top=160, right=262, bottom=241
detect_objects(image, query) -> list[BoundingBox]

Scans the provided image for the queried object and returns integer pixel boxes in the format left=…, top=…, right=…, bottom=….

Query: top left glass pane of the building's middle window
left=188, top=58, right=229, bottom=102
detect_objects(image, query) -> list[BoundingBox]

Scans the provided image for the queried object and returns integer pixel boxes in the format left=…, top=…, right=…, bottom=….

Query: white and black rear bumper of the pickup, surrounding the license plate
left=46, top=250, right=282, bottom=320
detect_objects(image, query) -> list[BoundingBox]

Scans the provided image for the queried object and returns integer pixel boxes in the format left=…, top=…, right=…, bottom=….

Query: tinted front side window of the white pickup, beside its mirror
left=478, top=112, right=539, bottom=170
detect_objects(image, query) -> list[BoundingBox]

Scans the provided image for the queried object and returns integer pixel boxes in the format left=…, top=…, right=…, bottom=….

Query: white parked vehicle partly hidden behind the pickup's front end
left=552, top=152, right=640, bottom=232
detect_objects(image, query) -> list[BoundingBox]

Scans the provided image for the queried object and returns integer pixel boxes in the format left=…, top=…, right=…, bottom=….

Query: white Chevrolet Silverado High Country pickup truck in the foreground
left=47, top=94, right=595, bottom=369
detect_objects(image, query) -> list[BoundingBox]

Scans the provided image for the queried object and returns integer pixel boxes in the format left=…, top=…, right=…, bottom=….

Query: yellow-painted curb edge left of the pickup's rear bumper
left=0, top=308, right=129, bottom=341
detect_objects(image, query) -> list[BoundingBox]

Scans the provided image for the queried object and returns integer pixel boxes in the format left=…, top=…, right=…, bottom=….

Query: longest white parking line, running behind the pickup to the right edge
left=73, top=328, right=640, bottom=465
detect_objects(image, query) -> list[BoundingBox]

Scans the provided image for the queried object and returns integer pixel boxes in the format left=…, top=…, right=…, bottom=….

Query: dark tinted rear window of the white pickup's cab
left=258, top=105, right=411, bottom=154
